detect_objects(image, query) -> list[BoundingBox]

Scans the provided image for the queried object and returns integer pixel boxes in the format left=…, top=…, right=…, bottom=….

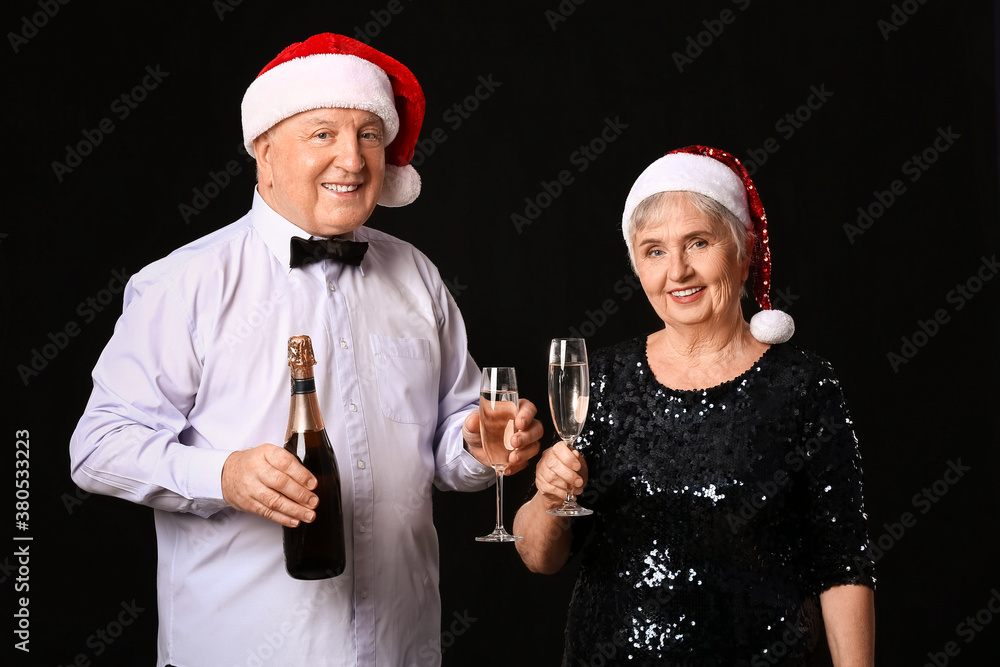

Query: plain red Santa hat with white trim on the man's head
left=242, top=33, right=424, bottom=206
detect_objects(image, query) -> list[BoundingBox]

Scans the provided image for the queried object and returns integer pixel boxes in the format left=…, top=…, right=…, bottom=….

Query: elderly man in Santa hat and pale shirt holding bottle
left=70, top=34, right=542, bottom=667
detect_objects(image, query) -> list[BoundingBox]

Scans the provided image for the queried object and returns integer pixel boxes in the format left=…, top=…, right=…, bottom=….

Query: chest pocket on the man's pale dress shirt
left=371, top=334, right=437, bottom=425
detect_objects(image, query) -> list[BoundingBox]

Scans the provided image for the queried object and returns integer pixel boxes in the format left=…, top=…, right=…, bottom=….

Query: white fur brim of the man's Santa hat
left=243, top=53, right=398, bottom=157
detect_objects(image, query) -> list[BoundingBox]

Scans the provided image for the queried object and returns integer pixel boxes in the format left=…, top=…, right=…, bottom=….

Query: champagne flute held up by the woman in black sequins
left=548, top=338, right=594, bottom=516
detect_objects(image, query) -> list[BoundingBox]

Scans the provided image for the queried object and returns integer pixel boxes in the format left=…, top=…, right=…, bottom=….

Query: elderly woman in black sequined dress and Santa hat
left=514, top=146, right=875, bottom=667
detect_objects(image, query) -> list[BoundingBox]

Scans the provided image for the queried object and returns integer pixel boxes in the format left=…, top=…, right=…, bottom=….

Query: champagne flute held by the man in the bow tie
left=476, top=367, right=524, bottom=542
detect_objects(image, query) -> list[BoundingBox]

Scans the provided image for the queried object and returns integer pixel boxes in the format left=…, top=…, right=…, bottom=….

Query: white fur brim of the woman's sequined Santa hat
left=622, top=153, right=753, bottom=243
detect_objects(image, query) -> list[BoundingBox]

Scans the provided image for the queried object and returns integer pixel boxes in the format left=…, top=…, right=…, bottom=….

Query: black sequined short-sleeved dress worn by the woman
left=563, top=337, right=875, bottom=667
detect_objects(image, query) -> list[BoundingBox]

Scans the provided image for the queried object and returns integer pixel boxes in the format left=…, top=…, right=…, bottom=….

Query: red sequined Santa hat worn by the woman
left=622, top=146, right=795, bottom=344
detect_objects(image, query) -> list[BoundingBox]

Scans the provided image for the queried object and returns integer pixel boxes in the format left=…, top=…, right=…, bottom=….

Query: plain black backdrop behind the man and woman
left=0, top=0, right=1000, bottom=665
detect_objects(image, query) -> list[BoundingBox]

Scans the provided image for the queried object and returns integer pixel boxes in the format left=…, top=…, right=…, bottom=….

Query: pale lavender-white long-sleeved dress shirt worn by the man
left=70, top=192, right=495, bottom=667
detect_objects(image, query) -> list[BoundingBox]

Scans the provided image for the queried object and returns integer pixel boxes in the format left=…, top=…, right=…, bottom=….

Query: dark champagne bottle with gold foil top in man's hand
left=284, top=336, right=346, bottom=579
